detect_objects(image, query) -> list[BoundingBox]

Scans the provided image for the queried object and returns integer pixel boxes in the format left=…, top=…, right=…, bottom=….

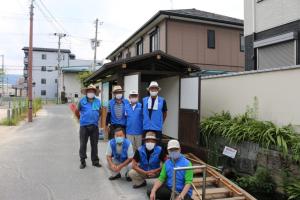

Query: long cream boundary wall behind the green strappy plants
left=201, top=66, right=300, bottom=130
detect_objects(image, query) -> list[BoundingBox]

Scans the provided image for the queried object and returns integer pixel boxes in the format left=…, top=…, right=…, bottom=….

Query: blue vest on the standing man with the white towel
left=143, top=96, right=164, bottom=131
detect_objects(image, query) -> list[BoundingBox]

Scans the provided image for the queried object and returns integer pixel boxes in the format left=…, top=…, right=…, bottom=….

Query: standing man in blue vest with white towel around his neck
left=143, top=81, right=168, bottom=143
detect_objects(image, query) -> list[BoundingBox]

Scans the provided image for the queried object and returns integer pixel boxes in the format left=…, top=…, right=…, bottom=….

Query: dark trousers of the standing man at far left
left=79, top=125, right=99, bottom=164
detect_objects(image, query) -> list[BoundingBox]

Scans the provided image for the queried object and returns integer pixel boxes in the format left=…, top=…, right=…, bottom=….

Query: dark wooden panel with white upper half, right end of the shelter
left=179, top=77, right=201, bottom=147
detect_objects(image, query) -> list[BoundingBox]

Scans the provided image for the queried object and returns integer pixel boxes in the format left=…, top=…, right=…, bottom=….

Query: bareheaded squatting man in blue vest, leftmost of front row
left=106, top=128, right=133, bottom=181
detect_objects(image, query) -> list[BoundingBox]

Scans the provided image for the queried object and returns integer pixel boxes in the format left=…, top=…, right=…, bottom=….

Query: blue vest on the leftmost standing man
left=79, top=96, right=101, bottom=126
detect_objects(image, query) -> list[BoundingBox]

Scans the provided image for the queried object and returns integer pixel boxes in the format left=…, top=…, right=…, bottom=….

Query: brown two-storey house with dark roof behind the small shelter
left=107, top=9, right=244, bottom=74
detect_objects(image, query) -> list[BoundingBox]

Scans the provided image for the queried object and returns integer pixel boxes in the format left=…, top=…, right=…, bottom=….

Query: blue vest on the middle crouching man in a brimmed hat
left=138, top=145, right=161, bottom=171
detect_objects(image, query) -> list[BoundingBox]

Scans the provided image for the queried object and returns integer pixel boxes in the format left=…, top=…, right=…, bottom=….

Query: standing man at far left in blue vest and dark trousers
left=75, top=85, right=101, bottom=169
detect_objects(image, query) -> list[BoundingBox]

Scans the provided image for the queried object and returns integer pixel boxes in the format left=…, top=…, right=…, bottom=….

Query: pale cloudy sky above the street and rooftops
left=0, top=0, right=244, bottom=74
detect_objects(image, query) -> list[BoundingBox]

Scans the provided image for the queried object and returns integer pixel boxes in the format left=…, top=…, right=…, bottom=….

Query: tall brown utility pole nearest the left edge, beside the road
left=27, top=0, right=34, bottom=122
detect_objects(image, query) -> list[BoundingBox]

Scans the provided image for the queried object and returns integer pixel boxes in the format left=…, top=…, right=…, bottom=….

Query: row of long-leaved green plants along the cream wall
left=200, top=112, right=300, bottom=162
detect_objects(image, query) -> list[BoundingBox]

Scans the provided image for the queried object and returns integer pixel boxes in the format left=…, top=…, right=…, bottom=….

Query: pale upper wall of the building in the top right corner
left=244, top=0, right=300, bottom=36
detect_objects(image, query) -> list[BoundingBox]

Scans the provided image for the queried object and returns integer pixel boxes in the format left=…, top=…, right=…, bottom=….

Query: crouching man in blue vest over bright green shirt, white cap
left=147, top=140, right=193, bottom=200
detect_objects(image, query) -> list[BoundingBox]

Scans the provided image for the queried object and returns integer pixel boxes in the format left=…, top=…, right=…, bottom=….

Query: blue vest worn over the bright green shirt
left=165, top=155, right=192, bottom=197
